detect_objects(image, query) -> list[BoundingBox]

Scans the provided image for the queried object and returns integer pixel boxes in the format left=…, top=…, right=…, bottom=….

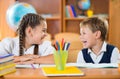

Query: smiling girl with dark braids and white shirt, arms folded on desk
left=0, top=13, right=54, bottom=64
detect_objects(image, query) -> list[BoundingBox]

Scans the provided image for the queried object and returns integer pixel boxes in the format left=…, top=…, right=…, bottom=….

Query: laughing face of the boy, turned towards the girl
left=80, top=26, right=97, bottom=48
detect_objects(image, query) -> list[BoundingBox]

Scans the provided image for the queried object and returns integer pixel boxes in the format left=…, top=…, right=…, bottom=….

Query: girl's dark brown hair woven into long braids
left=17, top=13, right=45, bottom=56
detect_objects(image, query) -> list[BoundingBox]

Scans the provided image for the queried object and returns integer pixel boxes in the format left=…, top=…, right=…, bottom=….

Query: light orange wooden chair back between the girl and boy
left=55, top=32, right=83, bottom=62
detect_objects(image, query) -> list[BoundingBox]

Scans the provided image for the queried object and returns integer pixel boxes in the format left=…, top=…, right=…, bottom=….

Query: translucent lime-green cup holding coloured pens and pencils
left=54, top=50, right=68, bottom=70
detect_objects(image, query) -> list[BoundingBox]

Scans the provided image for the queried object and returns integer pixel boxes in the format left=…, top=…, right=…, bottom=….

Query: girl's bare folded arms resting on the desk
left=14, top=54, right=54, bottom=64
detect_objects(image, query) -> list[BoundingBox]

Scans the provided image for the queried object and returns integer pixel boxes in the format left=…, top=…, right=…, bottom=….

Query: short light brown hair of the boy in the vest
left=80, top=17, right=108, bottom=41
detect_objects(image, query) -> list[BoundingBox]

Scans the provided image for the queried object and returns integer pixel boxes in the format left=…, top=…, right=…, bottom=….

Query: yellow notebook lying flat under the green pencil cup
left=42, top=66, right=84, bottom=76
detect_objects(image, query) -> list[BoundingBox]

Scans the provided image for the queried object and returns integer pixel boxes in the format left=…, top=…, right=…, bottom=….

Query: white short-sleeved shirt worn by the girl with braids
left=0, top=37, right=55, bottom=56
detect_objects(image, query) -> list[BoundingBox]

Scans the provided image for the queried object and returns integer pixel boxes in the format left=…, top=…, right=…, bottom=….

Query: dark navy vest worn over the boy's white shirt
left=82, top=44, right=115, bottom=63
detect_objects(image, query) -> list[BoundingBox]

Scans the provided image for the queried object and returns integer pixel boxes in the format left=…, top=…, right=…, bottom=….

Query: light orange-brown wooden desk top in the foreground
left=0, top=68, right=120, bottom=79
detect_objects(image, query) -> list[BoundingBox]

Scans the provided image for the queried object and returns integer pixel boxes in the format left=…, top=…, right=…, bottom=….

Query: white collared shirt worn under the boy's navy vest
left=77, top=42, right=120, bottom=64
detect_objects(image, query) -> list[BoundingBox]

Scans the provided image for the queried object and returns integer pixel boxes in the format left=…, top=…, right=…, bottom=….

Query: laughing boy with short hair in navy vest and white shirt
left=77, top=17, right=119, bottom=64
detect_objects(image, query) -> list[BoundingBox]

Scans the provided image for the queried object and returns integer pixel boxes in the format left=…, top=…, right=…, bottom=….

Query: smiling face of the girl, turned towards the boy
left=29, top=21, right=47, bottom=44
